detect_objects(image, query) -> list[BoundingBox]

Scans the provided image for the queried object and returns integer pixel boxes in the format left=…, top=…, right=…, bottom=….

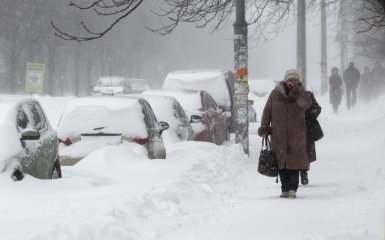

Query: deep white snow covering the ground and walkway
left=0, top=92, right=385, bottom=240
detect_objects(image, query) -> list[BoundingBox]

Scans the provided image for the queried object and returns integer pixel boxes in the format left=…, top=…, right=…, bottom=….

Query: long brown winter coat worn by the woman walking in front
left=258, top=82, right=311, bottom=169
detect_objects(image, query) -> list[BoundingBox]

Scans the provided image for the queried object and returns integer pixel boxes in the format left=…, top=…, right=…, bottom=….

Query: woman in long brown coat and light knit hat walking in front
left=258, top=69, right=311, bottom=198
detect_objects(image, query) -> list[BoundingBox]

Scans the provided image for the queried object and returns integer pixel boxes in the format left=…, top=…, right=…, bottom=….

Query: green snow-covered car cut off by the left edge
left=0, top=95, right=61, bottom=180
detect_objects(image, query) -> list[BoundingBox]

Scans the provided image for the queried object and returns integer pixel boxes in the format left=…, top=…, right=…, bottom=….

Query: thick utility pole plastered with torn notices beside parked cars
left=233, top=0, right=249, bottom=155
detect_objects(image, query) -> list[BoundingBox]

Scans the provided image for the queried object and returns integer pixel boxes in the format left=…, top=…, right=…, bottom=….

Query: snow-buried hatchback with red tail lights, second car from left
left=57, top=96, right=169, bottom=165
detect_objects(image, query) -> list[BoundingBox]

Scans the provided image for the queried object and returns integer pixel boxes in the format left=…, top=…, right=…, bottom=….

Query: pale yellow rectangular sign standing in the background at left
left=25, top=63, right=45, bottom=93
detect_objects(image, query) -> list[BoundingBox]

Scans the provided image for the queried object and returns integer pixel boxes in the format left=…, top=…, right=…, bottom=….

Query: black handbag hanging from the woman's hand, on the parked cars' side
left=258, top=137, right=278, bottom=177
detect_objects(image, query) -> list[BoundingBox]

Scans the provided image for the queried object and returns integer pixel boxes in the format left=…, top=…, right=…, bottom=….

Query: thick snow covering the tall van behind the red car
left=162, top=70, right=231, bottom=106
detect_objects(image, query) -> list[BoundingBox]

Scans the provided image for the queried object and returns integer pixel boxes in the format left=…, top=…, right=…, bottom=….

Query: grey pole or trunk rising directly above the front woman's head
left=297, top=0, right=307, bottom=88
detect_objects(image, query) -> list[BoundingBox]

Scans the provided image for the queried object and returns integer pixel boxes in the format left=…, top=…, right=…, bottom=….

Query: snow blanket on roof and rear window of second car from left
left=57, top=97, right=147, bottom=138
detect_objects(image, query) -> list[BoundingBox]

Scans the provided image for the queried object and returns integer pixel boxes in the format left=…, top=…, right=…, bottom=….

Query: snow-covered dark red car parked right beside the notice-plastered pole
left=144, top=89, right=230, bottom=145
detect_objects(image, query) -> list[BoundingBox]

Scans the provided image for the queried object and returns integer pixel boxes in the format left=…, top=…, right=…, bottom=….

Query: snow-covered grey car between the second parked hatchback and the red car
left=141, top=93, right=194, bottom=143
